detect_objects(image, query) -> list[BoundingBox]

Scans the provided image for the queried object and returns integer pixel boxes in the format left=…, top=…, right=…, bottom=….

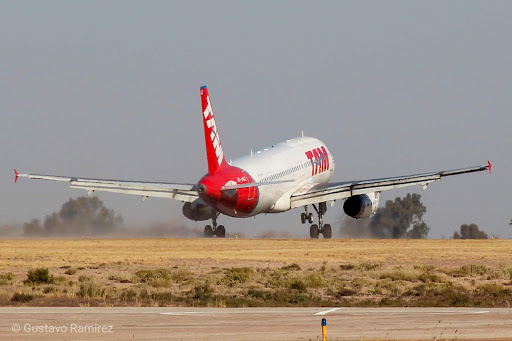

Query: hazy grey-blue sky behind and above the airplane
left=0, top=1, right=512, bottom=237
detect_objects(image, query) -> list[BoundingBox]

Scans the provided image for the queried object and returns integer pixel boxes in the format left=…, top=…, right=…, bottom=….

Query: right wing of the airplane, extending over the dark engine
left=291, top=161, right=491, bottom=208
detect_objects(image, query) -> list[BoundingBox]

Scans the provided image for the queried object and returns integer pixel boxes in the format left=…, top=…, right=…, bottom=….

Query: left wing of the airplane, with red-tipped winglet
left=14, top=170, right=199, bottom=202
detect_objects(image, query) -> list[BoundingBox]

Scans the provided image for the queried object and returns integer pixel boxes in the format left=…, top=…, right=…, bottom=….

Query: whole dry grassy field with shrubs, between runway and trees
left=0, top=239, right=512, bottom=307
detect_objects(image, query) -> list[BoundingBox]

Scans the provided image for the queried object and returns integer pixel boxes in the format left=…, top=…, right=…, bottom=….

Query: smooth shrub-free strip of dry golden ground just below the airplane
left=0, top=238, right=512, bottom=271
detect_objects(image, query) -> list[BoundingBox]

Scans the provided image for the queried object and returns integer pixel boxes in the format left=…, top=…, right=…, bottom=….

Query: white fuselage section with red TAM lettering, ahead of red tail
left=231, top=137, right=335, bottom=215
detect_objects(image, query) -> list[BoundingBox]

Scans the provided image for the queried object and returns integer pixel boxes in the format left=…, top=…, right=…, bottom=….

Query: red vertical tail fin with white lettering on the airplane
left=201, top=85, right=227, bottom=174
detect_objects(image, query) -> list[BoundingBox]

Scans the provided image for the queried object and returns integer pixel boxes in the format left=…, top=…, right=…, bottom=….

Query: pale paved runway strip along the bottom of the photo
left=0, top=307, right=512, bottom=340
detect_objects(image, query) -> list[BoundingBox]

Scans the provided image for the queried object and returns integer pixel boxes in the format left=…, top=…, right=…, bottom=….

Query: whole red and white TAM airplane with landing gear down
left=14, top=86, right=492, bottom=239
